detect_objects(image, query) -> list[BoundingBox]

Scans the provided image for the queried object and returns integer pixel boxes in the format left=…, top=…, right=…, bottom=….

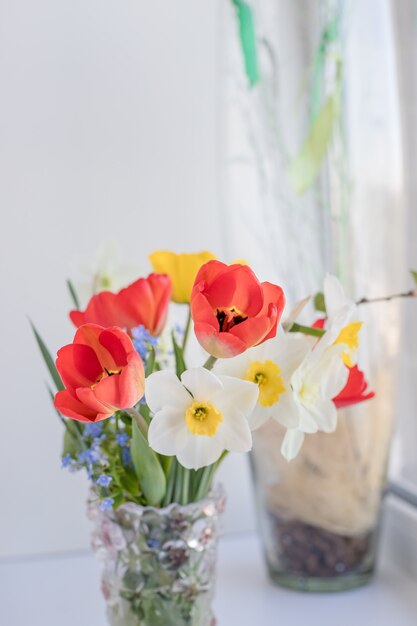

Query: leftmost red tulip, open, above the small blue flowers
left=54, top=324, right=145, bottom=422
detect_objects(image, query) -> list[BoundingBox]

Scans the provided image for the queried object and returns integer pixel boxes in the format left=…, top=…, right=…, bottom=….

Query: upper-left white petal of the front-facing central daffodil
left=145, top=370, right=192, bottom=413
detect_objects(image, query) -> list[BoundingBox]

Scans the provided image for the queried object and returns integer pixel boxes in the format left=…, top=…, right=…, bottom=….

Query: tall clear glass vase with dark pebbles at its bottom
left=224, top=0, right=406, bottom=590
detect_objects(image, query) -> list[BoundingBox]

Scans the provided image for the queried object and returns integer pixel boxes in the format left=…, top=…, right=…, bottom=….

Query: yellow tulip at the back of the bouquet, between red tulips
left=149, top=250, right=216, bottom=304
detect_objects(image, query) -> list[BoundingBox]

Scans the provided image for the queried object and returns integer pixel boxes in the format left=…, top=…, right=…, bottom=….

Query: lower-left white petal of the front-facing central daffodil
left=148, top=408, right=187, bottom=456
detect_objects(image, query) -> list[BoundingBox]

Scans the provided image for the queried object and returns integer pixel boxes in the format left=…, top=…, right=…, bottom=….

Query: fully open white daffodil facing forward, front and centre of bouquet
left=145, top=367, right=258, bottom=469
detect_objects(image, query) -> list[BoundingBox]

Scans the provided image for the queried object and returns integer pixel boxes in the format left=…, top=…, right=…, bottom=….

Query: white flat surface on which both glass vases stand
left=0, top=534, right=417, bottom=626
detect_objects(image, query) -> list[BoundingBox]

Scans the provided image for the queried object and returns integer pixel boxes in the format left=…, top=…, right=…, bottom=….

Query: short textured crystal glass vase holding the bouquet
left=89, top=487, right=225, bottom=626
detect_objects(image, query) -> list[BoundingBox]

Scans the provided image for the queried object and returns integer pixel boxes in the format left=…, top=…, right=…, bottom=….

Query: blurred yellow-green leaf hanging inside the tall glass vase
left=289, top=90, right=339, bottom=194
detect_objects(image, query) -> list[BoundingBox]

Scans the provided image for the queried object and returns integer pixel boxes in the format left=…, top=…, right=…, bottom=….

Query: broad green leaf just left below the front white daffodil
left=130, top=420, right=166, bottom=506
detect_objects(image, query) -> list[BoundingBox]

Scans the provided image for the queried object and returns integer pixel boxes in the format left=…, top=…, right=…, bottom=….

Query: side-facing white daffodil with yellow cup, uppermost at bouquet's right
left=324, top=274, right=362, bottom=367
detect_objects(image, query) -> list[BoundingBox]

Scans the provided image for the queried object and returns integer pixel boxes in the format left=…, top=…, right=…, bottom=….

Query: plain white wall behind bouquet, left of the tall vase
left=0, top=0, right=253, bottom=557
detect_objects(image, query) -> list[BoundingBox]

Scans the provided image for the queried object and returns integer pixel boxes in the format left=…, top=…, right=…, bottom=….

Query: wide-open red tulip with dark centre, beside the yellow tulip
left=191, top=261, right=285, bottom=358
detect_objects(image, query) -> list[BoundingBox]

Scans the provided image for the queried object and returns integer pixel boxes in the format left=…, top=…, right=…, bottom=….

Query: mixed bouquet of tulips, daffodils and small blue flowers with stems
left=34, top=251, right=414, bottom=624
